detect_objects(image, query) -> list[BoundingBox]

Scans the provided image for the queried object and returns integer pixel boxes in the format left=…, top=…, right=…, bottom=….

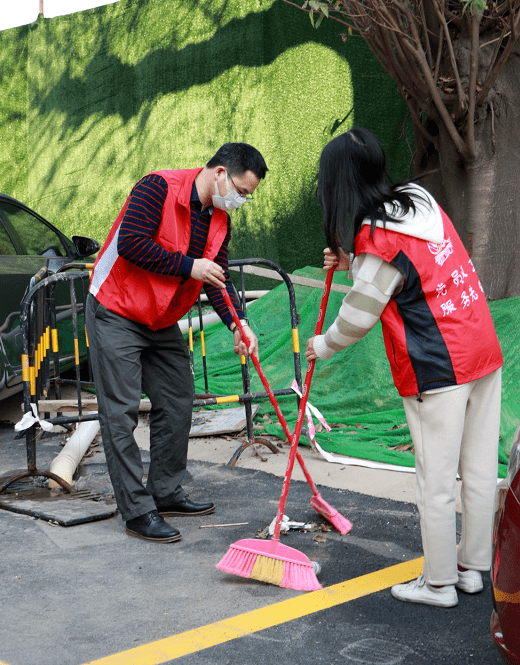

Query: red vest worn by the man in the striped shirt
left=90, top=169, right=228, bottom=330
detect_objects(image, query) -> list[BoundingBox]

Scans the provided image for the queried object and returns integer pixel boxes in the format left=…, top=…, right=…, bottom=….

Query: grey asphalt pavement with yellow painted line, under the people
left=0, top=394, right=501, bottom=665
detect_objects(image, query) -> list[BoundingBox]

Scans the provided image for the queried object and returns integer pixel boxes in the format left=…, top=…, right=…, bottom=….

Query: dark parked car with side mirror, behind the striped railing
left=0, top=189, right=100, bottom=400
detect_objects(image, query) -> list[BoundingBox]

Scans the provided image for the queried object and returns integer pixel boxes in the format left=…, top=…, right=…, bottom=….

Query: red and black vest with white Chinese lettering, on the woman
left=355, top=209, right=503, bottom=397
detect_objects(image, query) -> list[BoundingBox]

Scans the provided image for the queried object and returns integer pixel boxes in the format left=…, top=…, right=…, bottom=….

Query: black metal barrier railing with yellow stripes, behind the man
left=0, top=258, right=302, bottom=493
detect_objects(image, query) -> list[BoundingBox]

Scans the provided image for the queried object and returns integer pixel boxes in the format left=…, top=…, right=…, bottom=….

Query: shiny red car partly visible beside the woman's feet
left=491, top=426, right=520, bottom=665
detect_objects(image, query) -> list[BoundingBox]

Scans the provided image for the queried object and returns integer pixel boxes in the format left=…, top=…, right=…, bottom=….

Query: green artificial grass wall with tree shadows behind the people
left=0, top=0, right=411, bottom=272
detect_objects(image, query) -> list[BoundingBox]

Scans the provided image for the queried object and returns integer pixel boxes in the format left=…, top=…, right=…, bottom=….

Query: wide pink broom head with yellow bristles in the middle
left=217, top=538, right=322, bottom=591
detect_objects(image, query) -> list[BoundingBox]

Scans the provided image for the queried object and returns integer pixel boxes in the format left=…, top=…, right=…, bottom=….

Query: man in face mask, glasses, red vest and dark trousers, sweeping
left=86, top=143, right=267, bottom=543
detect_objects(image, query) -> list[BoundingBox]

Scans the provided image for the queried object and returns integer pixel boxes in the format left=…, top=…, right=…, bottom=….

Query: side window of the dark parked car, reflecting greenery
left=2, top=201, right=67, bottom=256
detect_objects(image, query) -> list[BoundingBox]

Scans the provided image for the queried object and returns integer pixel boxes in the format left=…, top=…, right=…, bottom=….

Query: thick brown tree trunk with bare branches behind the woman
left=284, top=0, right=520, bottom=300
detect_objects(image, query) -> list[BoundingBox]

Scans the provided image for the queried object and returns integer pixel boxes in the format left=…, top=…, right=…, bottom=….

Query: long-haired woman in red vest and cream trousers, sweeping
left=305, top=127, right=503, bottom=607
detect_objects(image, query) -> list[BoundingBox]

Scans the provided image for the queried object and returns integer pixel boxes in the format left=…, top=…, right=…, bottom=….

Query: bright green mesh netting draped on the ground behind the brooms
left=188, top=267, right=520, bottom=478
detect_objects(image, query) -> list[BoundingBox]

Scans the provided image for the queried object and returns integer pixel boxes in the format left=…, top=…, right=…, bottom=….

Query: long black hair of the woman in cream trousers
left=317, top=127, right=422, bottom=254
